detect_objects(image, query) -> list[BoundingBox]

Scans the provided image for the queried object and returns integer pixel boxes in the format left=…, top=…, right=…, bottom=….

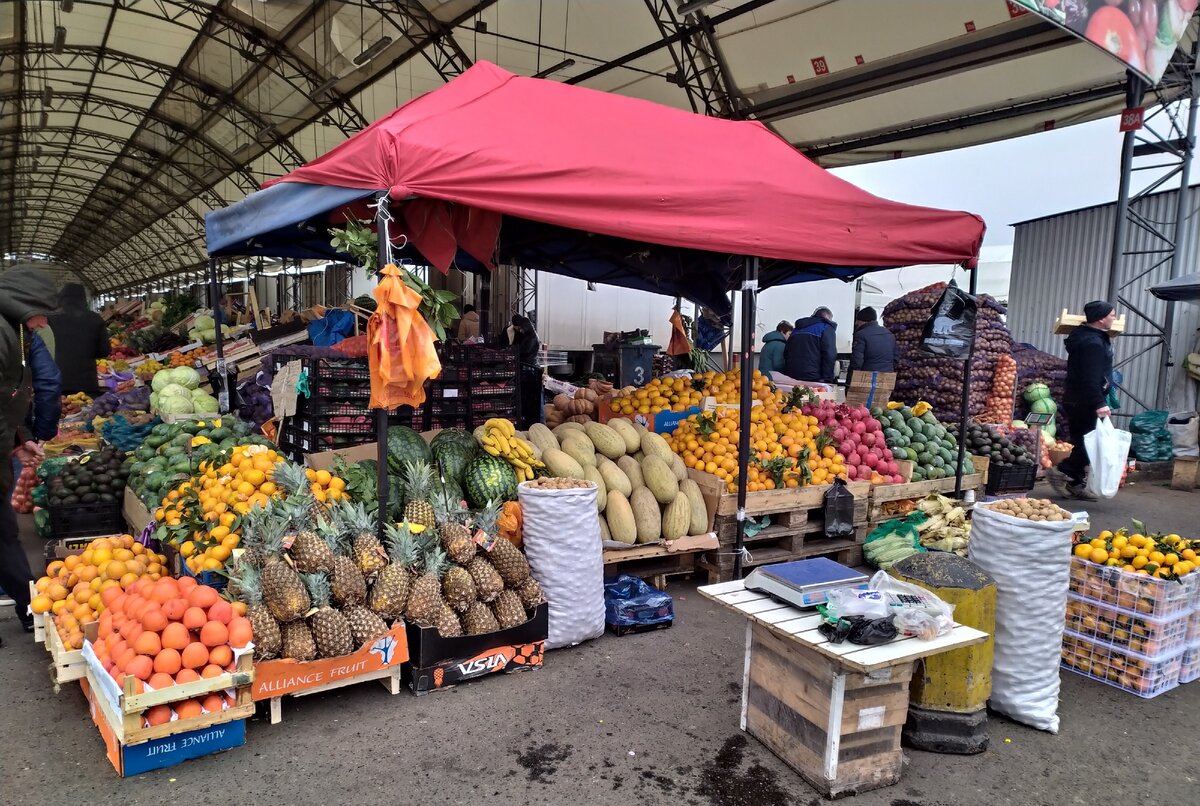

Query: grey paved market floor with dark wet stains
left=0, top=474, right=1200, bottom=806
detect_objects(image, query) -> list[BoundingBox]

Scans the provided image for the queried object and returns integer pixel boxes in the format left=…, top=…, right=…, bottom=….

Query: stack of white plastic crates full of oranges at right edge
left=1062, top=557, right=1200, bottom=698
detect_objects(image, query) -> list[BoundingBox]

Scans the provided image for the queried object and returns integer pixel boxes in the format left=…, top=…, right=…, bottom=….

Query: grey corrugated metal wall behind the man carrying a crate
left=1008, top=187, right=1200, bottom=415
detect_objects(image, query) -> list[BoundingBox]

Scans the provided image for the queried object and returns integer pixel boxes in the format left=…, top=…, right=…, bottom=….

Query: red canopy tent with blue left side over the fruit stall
left=205, top=62, right=984, bottom=566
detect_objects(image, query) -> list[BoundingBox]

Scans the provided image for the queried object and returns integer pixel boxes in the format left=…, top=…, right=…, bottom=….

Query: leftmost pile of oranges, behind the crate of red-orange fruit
left=30, top=535, right=168, bottom=649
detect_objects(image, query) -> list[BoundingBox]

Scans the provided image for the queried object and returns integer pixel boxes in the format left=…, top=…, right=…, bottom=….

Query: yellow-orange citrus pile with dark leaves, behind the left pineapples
left=155, top=445, right=347, bottom=575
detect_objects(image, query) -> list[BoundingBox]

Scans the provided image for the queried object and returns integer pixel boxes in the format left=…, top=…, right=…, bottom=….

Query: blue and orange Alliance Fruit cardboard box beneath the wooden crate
left=79, top=678, right=246, bottom=778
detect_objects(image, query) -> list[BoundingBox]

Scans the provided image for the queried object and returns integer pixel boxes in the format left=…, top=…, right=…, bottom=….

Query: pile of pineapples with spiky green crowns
left=229, top=463, right=545, bottom=661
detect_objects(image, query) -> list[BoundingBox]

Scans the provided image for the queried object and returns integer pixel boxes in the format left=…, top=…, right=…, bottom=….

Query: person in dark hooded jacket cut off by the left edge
left=0, top=267, right=61, bottom=630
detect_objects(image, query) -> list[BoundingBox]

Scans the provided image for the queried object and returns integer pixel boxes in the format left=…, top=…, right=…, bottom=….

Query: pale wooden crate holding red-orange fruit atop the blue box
left=86, top=652, right=254, bottom=746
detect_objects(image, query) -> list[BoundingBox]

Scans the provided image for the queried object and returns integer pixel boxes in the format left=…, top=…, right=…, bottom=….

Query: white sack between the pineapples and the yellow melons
left=517, top=483, right=604, bottom=649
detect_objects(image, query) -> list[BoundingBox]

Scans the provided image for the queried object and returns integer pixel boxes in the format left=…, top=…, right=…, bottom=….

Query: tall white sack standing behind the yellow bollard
left=967, top=503, right=1089, bottom=733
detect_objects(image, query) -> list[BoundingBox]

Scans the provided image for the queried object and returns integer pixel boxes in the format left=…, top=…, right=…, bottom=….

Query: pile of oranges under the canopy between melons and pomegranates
left=666, top=371, right=846, bottom=492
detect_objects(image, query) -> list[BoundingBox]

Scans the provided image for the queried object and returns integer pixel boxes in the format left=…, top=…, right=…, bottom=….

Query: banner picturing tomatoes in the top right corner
left=1010, top=0, right=1200, bottom=84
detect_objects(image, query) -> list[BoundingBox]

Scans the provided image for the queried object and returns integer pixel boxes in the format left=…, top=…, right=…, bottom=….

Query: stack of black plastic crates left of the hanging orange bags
left=274, top=356, right=424, bottom=461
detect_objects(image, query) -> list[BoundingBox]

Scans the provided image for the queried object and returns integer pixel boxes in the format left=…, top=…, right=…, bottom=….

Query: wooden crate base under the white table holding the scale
left=742, top=624, right=912, bottom=798
